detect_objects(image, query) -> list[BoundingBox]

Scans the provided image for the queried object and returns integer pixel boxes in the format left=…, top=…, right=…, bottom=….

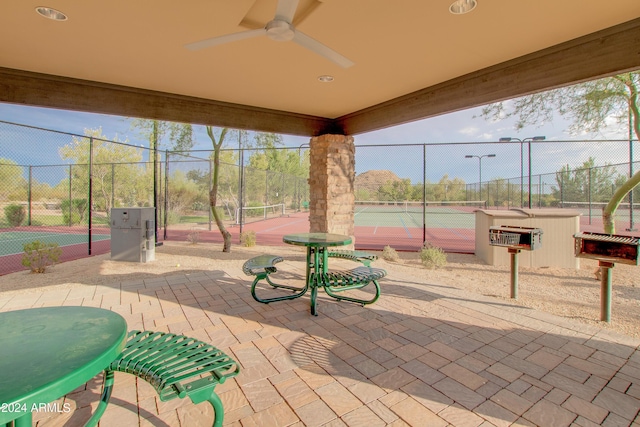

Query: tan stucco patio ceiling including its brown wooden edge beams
left=0, top=0, right=640, bottom=135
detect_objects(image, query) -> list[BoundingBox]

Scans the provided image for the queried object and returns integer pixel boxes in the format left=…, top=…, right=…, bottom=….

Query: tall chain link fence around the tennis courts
left=0, top=121, right=640, bottom=274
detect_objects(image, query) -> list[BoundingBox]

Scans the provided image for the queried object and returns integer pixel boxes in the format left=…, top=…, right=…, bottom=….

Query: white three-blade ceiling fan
left=185, top=0, right=354, bottom=68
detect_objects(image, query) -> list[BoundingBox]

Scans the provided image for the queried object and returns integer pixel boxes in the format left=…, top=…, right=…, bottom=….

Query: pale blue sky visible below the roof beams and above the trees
left=0, top=103, right=629, bottom=183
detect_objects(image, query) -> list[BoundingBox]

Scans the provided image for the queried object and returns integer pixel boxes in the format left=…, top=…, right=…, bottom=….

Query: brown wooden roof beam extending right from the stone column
left=336, top=19, right=640, bottom=135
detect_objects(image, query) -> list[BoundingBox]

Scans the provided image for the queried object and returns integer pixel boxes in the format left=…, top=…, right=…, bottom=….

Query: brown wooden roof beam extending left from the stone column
left=0, top=67, right=342, bottom=136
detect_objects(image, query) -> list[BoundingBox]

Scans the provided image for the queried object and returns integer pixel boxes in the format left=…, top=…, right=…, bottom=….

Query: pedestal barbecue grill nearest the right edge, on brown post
left=573, top=232, right=640, bottom=322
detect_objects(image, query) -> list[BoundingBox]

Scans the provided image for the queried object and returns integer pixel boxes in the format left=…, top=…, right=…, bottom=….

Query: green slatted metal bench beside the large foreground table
left=87, top=331, right=240, bottom=427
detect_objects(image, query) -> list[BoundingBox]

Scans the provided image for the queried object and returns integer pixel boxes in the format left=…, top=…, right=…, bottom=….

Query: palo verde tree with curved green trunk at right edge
left=481, top=71, right=640, bottom=234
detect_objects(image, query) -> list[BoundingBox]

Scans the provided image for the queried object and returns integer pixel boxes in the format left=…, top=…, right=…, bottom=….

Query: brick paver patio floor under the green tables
left=0, top=251, right=640, bottom=427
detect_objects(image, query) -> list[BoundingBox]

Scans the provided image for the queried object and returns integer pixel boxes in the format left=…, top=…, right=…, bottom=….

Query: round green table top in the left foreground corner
left=0, top=306, right=127, bottom=425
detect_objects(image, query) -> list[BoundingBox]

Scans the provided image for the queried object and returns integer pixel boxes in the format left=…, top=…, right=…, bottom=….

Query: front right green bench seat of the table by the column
left=311, top=266, right=387, bottom=305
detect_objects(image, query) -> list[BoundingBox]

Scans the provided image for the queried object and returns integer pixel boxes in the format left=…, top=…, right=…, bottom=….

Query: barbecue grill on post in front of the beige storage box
left=489, top=225, right=542, bottom=299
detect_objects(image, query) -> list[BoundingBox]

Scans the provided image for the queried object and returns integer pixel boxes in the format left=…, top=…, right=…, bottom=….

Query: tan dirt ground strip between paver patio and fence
left=0, top=242, right=640, bottom=337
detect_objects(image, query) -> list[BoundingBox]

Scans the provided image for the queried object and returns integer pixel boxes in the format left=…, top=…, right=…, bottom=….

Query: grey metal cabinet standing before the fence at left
left=111, top=208, right=156, bottom=262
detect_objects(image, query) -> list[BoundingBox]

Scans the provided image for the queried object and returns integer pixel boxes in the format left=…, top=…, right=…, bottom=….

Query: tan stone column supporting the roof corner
left=309, top=135, right=355, bottom=241
